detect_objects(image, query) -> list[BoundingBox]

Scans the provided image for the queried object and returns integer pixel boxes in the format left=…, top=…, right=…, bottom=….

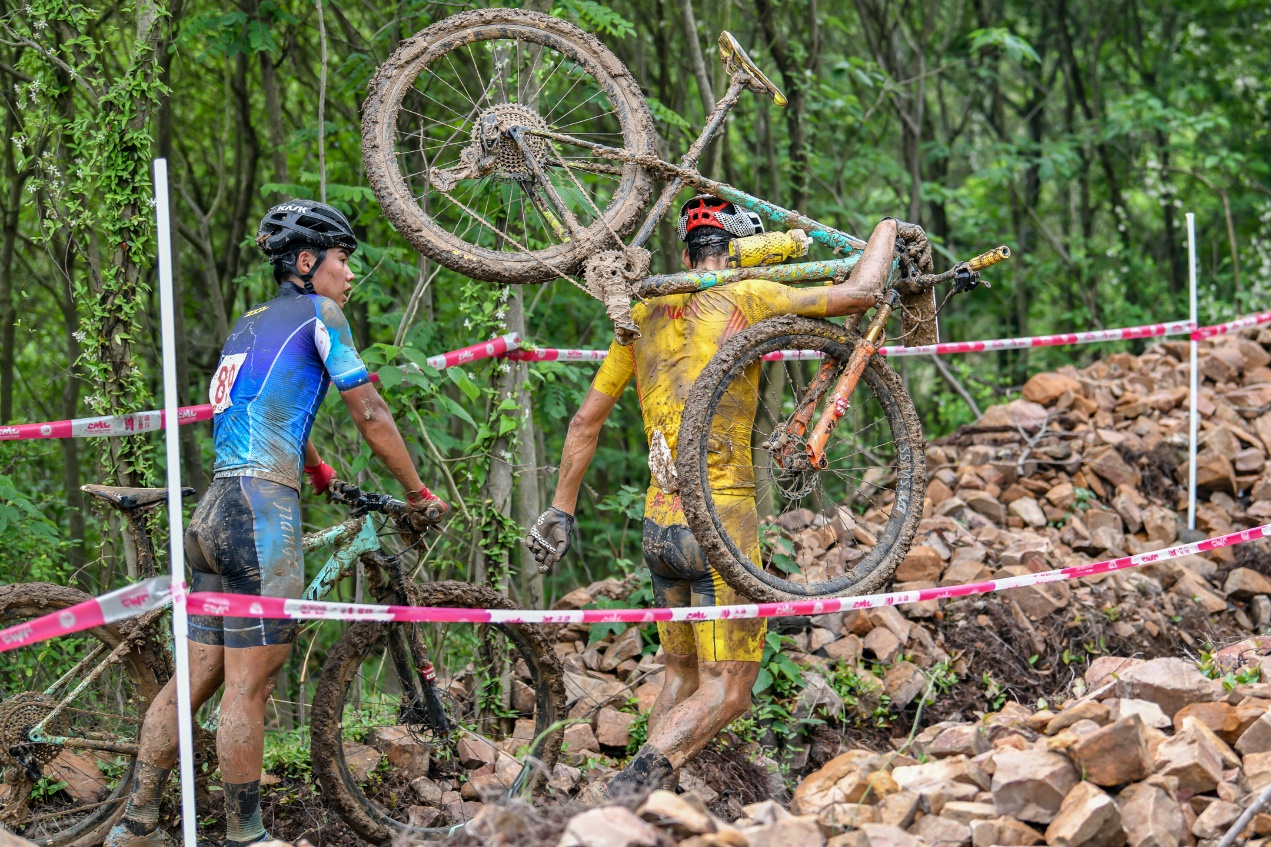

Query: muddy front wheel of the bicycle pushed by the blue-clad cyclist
left=310, top=582, right=566, bottom=843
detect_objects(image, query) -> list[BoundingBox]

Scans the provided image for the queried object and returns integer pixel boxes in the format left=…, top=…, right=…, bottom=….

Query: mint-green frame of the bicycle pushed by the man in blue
left=27, top=516, right=383, bottom=755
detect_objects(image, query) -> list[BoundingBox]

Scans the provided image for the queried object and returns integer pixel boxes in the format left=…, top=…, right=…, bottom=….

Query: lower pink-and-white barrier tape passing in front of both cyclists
left=7, top=524, right=1271, bottom=652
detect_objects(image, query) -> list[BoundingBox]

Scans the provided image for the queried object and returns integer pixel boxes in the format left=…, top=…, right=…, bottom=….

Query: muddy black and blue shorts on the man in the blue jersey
left=186, top=477, right=305, bottom=647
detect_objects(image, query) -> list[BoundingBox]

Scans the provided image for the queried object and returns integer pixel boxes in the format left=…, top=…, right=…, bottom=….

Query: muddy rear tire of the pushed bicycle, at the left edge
left=0, top=582, right=167, bottom=847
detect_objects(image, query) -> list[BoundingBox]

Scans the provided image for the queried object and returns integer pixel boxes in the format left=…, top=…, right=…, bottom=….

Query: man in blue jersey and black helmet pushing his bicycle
left=105, top=200, right=449, bottom=847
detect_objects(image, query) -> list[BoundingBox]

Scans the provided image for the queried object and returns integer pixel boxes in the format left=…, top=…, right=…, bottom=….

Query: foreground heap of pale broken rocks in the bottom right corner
left=791, top=638, right=1271, bottom=847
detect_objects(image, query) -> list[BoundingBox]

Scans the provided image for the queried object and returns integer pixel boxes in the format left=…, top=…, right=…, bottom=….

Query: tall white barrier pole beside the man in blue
left=155, top=159, right=198, bottom=847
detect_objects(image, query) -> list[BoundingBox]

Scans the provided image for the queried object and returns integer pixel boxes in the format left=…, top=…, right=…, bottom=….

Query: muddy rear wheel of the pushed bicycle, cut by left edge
left=0, top=582, right=161, bottom=847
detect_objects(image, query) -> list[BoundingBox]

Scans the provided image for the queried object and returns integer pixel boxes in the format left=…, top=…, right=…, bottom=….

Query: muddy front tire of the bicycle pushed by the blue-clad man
left=310, top=581, right=566, bottom=844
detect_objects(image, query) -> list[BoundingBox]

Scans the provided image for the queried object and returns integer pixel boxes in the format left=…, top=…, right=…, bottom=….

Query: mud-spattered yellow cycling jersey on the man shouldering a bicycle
left=591, top=280, right=829, bottom=495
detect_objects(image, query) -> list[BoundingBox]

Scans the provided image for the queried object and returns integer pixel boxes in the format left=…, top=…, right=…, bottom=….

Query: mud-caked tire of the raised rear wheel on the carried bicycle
left=362, top=9, right=657, bottom=285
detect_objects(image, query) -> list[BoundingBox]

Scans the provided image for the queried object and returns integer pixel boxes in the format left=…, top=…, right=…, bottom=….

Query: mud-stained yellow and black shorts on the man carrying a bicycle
left=643, top=488, right=768, bottom=661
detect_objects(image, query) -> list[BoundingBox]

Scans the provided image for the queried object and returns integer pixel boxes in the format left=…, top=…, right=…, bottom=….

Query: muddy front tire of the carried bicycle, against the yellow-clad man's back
left=676, top=315, right=927, bottom=603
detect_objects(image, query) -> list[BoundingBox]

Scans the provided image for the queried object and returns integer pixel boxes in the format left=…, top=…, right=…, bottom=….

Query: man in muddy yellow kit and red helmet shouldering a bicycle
left=525, top=196, right=896, bottom=796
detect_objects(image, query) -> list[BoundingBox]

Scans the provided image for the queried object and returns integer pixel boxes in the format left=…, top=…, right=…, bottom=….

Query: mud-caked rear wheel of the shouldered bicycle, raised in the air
left=362, top=9, right=656, bottom=284
